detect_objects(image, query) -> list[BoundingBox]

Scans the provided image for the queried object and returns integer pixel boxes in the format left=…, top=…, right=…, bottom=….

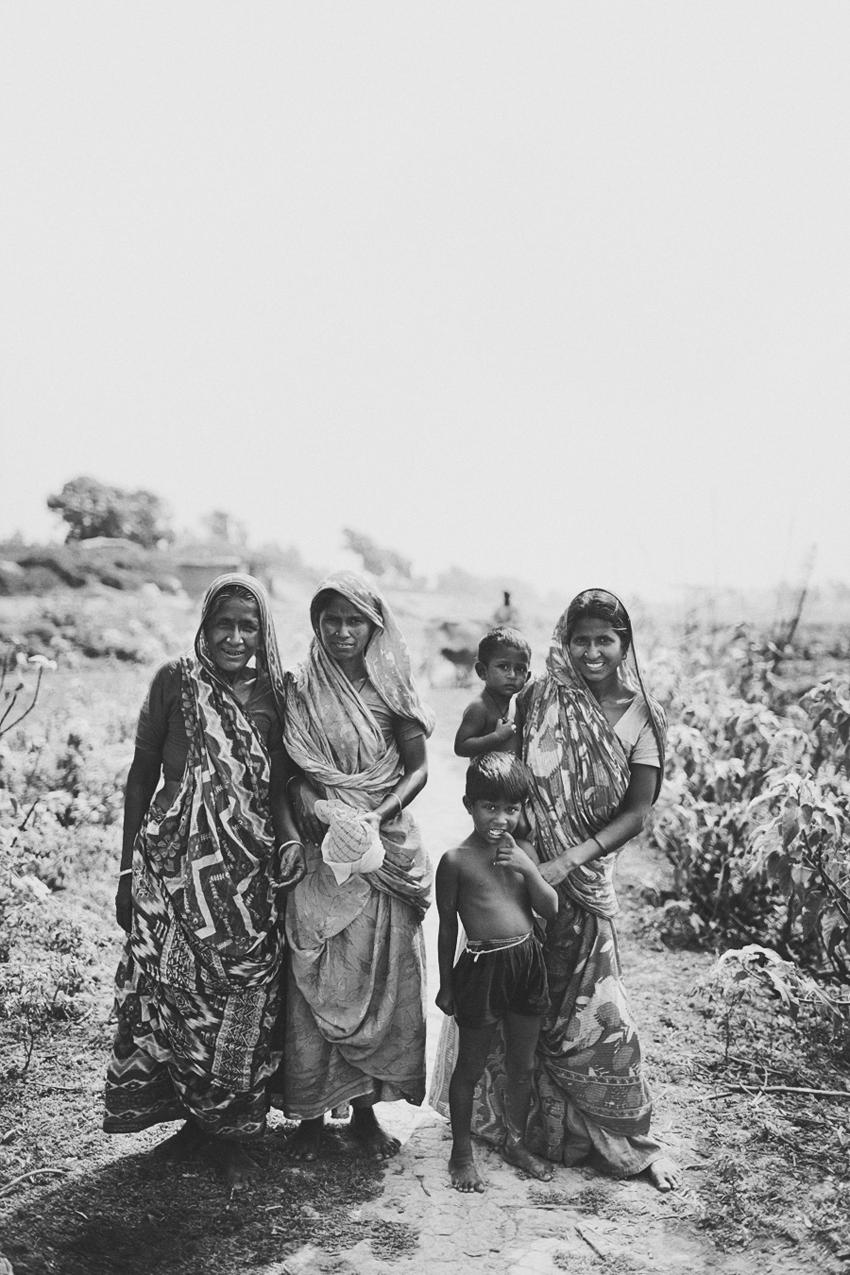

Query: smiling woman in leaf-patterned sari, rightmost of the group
left=436, top=589, right=681, bottom=1191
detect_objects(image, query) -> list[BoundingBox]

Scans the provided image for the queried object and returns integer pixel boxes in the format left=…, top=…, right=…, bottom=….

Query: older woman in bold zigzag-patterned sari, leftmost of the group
left=103, top=575, right=303, bottom=1182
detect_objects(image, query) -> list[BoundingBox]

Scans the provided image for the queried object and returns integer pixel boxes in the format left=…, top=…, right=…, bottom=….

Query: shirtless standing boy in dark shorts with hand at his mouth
left=437, top=752, right=558, bottom=1191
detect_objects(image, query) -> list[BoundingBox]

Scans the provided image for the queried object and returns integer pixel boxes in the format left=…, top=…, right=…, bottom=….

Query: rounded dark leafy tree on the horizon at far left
left=47, top=474, right=175, bottom=548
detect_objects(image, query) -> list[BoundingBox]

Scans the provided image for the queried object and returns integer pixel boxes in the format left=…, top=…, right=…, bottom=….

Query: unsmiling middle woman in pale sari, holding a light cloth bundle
left=273, top=572, right=433, bottom=1160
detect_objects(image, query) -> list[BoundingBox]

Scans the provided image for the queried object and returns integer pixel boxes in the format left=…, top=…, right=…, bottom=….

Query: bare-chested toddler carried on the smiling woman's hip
left=455, top=627, right=531, bottom=757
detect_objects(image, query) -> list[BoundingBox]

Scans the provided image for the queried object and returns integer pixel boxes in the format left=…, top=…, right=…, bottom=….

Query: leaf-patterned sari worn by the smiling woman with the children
left=431, top=596, right=666, bottom=1177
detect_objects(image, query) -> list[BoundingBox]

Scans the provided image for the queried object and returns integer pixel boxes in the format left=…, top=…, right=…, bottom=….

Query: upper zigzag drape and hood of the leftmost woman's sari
left=131, top=572, right=283, bottom=987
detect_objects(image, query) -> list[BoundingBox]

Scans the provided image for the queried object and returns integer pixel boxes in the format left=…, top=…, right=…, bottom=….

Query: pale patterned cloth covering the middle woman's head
left=305, top=571, right=435, bottom=734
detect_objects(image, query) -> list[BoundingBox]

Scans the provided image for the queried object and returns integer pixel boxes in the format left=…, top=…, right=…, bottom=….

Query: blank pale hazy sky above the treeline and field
left=0, top=0, right=850, bottom=594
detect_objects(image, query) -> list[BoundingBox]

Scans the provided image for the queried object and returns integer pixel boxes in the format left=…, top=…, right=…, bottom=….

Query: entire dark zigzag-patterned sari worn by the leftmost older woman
left=103, top=575, right=282, bottom=1139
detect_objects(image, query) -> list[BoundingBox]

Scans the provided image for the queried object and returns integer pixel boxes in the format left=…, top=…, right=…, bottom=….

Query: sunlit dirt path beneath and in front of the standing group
left=0, top=691, right=846, bottom=1275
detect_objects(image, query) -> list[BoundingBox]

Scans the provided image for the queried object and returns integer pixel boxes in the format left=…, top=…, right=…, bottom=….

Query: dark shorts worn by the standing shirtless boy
left=452, top=932, right=549, bottom=1028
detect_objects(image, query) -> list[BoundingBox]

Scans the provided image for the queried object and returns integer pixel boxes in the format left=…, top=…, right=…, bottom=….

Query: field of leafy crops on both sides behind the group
left=0, top=590, right=850, bottom=1271
